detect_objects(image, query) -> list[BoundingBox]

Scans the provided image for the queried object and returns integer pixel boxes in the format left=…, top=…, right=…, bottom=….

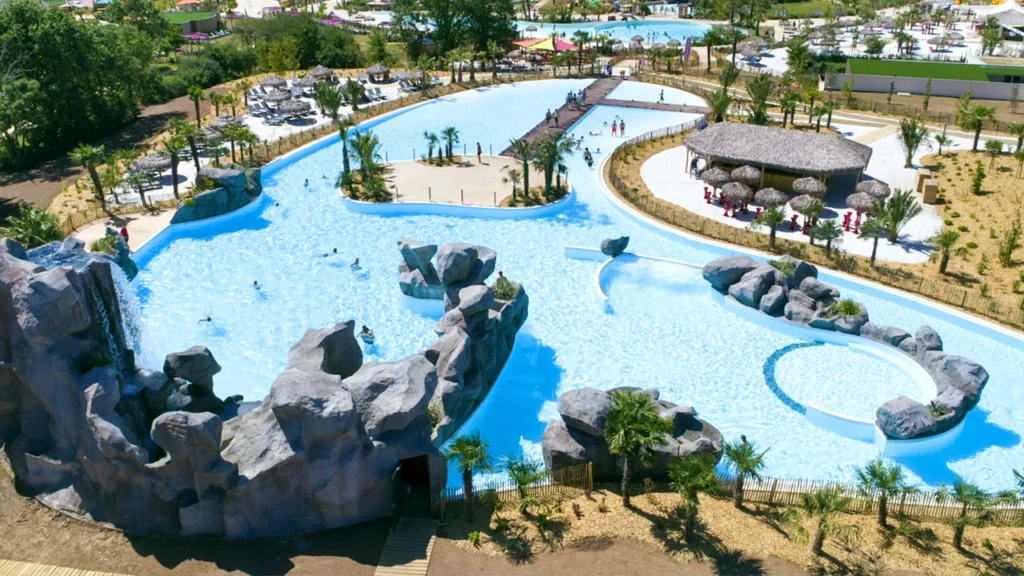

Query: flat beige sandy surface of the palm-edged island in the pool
left=387, top=153, right=544, bottom=206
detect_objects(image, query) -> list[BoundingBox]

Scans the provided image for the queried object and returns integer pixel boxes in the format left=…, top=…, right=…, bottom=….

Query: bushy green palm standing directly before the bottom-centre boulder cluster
left=604, top=390, right=672, bottom=507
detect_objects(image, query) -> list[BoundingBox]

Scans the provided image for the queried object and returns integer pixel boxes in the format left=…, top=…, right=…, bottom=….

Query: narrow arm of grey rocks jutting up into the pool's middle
left=398, top=238, right=529, bottom=445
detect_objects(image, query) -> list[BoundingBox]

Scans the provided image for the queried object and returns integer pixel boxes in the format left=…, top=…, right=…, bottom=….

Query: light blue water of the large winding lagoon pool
left=133, top=80, right=1024, bottom=489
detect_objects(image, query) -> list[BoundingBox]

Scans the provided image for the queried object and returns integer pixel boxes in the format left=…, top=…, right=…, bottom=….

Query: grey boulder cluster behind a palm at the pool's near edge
left=541, top=386, right=722, bottom=479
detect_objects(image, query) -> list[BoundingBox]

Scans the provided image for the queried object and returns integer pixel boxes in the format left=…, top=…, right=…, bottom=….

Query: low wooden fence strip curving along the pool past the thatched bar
left=608, top=123, right=1024, bottom=330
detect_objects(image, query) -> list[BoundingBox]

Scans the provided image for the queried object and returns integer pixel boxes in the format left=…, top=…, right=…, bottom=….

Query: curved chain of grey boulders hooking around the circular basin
left=703, top=255, right=988, bottom=440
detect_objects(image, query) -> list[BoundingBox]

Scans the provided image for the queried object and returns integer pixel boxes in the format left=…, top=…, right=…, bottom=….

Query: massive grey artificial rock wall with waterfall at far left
left=0, top=240, right=446, bottom=538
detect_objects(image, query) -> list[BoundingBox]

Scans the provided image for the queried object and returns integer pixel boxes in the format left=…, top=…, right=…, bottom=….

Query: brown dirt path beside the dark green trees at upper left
left=0, top=87, right=227, bottom=219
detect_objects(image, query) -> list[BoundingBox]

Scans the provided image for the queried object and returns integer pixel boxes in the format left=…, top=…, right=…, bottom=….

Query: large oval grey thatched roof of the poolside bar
left=685, top=122, right=871, bottom=176
